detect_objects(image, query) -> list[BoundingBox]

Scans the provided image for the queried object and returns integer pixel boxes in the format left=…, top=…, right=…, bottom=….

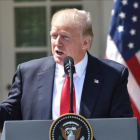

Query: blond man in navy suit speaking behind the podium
left=0, top=9, right=133, bottom=129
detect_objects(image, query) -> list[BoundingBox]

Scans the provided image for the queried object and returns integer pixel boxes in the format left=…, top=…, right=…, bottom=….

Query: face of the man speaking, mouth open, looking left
left=50, top=25, right=86, bottom=65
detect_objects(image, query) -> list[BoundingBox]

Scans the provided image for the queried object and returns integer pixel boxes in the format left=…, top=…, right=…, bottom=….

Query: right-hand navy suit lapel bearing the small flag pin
left=80, top=54, right=102, bottom=118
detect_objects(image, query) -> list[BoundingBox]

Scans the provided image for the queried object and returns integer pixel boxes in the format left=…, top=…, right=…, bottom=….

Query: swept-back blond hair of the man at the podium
left=51, top=8, right=93, bottom=48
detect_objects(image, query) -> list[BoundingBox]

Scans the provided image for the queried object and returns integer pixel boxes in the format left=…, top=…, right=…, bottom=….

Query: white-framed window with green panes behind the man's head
left=14, top=0, right=83, bottom=68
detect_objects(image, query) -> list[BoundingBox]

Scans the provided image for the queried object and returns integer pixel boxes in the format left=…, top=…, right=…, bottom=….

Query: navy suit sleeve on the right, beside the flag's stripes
left=110, top=67, right=133, bottom=118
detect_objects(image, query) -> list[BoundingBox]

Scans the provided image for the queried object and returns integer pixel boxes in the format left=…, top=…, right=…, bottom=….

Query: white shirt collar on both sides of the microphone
left=55, top=53, right=88, bottom=78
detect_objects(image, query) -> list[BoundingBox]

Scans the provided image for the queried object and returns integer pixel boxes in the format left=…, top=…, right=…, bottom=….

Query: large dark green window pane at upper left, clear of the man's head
left=15, top=7, right=47, bottom=47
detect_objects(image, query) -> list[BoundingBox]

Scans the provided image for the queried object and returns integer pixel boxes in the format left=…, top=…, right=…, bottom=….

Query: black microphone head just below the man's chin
left=64, top=56, right=75, bottom=77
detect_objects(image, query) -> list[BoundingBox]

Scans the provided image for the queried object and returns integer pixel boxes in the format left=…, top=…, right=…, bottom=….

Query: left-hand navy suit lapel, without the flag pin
left=38, top=57, right=55, bottom=119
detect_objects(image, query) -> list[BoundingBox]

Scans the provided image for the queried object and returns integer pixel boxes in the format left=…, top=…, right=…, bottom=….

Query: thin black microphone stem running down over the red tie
left=69, top=61, right=74, bottom=113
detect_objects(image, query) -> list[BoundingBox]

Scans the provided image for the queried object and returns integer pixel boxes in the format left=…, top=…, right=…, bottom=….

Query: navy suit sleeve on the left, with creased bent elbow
left=0, top=65, right=22, bottom=130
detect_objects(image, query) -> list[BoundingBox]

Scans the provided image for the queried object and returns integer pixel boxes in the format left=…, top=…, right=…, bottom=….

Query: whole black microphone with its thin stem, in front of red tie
left=64, top=56, right=75, bottom=113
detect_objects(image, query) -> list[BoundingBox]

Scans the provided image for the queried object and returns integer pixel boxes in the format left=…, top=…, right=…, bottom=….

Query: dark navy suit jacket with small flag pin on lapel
left=0, top=53, right=133, bottom=128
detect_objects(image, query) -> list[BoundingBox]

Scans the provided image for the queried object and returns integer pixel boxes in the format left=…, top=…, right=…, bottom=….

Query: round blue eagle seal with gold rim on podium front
left=49, top=113, right=93, bottom=140
